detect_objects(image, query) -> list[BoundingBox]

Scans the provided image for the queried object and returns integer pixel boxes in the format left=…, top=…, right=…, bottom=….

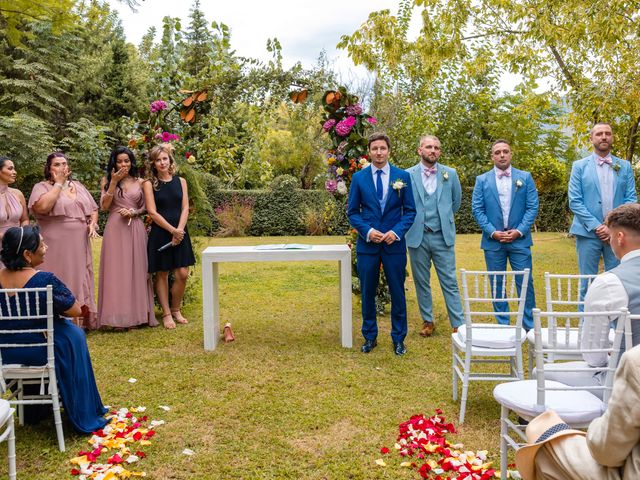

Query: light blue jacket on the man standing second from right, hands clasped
left=472, top=167, right=538, bottom=250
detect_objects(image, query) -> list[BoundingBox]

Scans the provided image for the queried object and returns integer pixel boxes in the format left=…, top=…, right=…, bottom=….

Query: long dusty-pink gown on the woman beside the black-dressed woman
left=98, top=182, right=158, bottom=328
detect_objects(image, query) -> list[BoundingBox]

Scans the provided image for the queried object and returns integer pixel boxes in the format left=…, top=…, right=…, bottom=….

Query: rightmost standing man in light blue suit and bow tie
left=569, top=123, right=637, bottom=298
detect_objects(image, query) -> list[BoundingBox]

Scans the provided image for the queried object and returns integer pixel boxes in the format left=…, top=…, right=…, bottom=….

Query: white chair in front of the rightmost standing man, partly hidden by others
left=527, top=272, right=597, bottom=377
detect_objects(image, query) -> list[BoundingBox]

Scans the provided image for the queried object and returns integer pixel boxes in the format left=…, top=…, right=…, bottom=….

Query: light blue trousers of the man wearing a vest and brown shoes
left=409, top=231, right=464, bottom=328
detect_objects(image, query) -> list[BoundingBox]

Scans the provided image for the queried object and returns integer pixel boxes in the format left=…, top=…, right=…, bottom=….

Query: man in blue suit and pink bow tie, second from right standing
left=472, top=140, right=538, bottom=331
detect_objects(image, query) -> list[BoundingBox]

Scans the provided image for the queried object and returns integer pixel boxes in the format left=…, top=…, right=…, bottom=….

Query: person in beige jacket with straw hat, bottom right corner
left=516, top=346, right=640, bottom=480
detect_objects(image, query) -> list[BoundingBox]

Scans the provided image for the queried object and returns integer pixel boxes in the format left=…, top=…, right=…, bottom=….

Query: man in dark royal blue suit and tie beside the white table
left=347, top=133, right=416, bottom=355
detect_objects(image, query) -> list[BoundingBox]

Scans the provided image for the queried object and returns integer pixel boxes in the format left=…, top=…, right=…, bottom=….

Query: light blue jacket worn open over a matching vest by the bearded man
left=407, top=162, right=462, bottom=248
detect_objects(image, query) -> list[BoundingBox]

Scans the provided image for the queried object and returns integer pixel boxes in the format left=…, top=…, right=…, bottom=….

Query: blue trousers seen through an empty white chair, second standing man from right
left=484, top=244, right=536, bottom=331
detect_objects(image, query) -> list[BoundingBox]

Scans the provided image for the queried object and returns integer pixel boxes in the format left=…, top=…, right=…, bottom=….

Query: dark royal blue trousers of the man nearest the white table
left=357, top=250, right=407, bottom=342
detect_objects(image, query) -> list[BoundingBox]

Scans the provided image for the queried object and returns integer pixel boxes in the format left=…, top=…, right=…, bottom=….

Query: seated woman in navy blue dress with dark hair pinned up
left=0, top=226, right=107, bottom=433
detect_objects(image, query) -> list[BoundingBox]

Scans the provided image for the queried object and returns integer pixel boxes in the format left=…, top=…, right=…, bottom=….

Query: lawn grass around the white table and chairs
left=0, top=233, right=577, bottom=479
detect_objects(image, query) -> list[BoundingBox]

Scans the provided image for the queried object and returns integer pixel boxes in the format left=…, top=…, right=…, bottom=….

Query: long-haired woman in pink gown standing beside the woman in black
left=98, top=146, right=158, bottom=328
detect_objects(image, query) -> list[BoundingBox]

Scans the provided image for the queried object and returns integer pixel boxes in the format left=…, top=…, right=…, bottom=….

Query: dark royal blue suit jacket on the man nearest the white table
left=347, top=165, right=416, bottom=254
